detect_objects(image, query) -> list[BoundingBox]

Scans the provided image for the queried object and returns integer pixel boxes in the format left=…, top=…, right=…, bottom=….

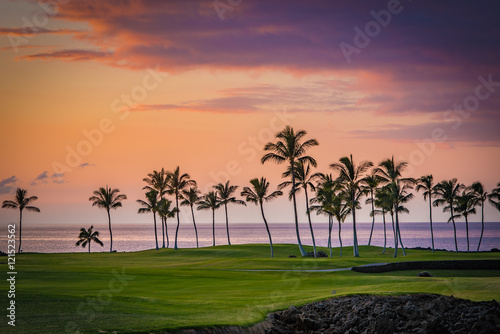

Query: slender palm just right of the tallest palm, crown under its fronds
left=278, top=161, right=320, bottom=257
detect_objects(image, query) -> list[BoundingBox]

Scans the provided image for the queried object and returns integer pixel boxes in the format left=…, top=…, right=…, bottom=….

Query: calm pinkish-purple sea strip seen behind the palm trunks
left=0, top=221, right=500, bottom=253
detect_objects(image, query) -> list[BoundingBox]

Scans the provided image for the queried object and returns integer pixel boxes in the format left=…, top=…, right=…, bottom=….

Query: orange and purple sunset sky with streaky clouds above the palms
left=0, top=0, right=500, bottom=227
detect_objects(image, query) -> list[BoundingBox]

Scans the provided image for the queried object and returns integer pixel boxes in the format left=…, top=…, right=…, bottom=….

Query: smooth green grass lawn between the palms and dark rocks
left=0, top=245, right=500, bottom=333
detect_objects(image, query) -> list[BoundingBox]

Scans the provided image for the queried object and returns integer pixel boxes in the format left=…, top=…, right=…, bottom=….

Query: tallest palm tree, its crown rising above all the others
left=261, top=125, right=318, bottom=256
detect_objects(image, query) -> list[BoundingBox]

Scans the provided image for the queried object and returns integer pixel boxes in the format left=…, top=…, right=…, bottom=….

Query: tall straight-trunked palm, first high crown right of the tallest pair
left=330, top=154, right=373, bottom=257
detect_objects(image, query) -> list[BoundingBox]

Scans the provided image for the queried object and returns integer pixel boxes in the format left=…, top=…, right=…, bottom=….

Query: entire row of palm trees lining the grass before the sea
left=2, top=126, right=500, bottom=257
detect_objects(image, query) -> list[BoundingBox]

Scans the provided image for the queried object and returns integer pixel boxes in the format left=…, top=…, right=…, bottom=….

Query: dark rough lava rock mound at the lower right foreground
left=173, top=294, right=500, bottom=334
